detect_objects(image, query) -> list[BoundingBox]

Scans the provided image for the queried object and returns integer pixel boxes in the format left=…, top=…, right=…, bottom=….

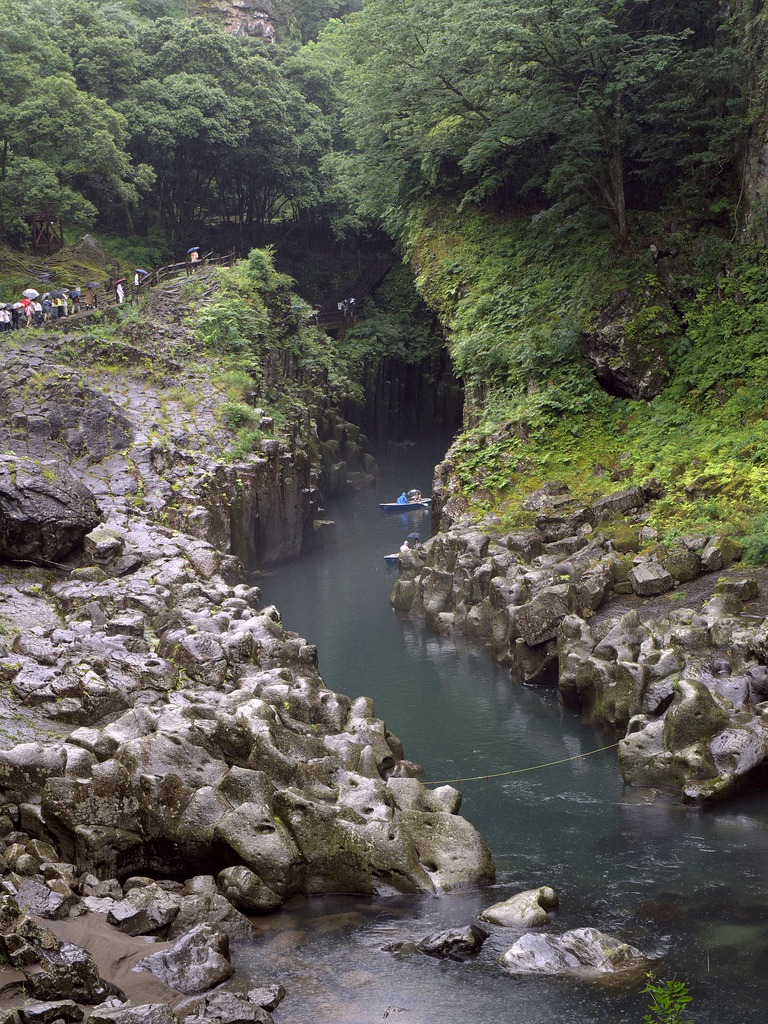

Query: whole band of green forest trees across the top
left=0, top=0, right=754, bottom=245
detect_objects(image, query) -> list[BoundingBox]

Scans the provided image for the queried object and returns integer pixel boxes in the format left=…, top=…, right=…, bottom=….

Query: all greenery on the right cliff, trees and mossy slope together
left=331, top=0, right=768, bottom=559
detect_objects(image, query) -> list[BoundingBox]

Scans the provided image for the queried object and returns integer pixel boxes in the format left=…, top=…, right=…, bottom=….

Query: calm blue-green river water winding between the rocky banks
left=238, top=442, right=768, bottom=1024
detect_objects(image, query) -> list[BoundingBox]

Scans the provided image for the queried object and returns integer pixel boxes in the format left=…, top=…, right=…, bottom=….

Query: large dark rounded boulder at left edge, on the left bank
left=0, top=456, right=100, bottom=563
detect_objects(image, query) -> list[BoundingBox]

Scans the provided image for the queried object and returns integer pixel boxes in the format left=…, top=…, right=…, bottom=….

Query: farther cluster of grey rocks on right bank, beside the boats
left=391, top=481, right=740, bottom=683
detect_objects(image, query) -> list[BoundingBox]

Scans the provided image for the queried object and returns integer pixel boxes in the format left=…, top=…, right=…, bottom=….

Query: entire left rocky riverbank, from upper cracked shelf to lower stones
left=0, top=280, right=494, bottom=1024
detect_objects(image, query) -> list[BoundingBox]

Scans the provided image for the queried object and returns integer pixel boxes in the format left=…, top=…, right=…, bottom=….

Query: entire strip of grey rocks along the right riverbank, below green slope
left=392, top=479, right=768, bottom=805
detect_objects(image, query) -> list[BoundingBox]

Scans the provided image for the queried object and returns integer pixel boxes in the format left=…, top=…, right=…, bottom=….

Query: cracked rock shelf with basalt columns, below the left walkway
left=0, top=274, right=376, bottom=570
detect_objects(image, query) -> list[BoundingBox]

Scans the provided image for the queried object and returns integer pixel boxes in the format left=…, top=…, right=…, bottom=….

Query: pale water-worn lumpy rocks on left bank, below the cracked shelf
left=0, top=507, right=494, bottom=892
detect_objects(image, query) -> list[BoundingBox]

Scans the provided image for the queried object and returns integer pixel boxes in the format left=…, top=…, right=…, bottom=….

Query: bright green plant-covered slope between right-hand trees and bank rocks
left=408, top=209, right=768, bottom=560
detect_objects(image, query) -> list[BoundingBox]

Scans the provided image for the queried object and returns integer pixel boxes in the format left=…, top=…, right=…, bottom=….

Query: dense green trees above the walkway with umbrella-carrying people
left=0, top=0, right=344, bottom=239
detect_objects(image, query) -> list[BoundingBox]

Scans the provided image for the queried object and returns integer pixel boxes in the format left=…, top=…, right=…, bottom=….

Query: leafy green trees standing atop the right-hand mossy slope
left=335, top=0, right=745, bottom=243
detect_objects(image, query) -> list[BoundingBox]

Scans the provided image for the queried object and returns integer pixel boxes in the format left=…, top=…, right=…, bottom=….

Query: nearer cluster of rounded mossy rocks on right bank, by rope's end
left=559, top=581, right=768, bottom=803
